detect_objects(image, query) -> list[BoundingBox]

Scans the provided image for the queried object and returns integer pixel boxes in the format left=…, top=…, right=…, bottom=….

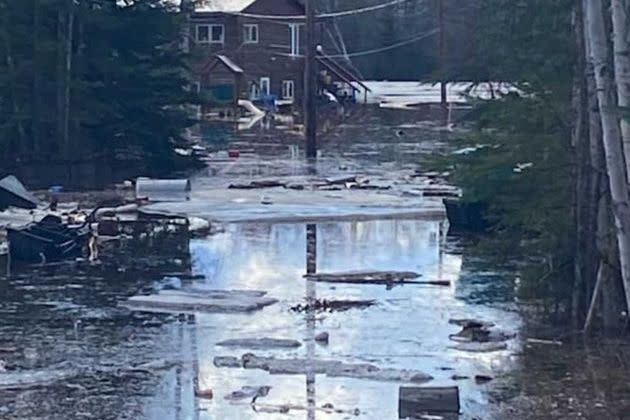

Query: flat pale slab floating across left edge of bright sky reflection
left=121, top=289, right=278, bottom=313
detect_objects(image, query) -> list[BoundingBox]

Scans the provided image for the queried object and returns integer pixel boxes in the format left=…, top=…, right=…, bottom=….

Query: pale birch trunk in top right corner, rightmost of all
left=610, top=0, right=630, bottom=174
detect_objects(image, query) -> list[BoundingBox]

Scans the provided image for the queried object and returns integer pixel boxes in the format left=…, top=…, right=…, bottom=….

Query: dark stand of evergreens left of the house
left=0, top=0, right=192, bottom=176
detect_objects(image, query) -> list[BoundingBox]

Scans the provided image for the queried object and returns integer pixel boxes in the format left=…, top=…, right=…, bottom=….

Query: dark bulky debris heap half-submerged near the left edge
left=7, top=216, right=90, bottom=263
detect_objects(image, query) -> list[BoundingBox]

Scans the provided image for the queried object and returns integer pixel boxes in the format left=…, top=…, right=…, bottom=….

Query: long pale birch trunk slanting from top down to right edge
left=584, top=0, right=630, bottom=314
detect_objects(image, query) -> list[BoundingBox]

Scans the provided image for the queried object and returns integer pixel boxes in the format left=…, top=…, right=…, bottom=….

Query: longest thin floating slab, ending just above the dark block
left=214, top=353, right=433, bottom=383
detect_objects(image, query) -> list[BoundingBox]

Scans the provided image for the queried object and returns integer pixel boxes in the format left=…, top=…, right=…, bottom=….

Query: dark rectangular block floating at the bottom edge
left=398, top=386, right=460, bottom=419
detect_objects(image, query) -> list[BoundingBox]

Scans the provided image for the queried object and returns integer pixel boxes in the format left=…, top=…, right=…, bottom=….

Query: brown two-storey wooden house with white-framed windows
left=188, top=0, right=367, bottom=111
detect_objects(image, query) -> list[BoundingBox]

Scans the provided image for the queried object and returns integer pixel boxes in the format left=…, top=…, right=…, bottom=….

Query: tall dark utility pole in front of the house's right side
left=304, top=0, right=317, bottom=159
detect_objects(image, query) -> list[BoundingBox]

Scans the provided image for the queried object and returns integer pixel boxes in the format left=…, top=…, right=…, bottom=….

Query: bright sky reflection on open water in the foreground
left=165, top=220, right=518, bottom=420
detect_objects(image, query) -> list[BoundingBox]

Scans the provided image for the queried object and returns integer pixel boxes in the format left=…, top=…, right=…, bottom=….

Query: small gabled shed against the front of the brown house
left=199, top=54, right=245, bottom=106
